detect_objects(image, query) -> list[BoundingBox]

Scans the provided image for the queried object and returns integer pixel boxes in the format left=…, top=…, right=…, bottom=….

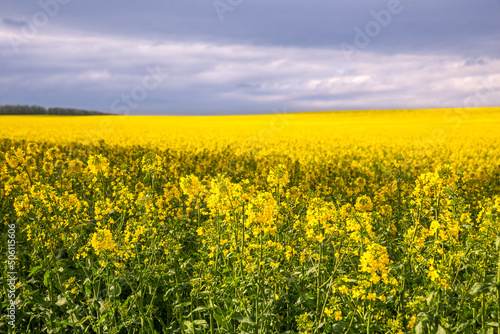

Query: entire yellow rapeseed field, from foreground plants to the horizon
left=0, top=108, right=500, bottom=334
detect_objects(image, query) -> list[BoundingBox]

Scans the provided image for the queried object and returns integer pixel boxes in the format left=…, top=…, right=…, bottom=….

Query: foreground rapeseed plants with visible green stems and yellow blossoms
left=0, top=140, right=500, bottom=334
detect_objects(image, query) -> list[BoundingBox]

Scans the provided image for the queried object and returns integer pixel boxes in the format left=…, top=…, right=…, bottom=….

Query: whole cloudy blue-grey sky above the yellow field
left=0, top=0, right=500, bottom=115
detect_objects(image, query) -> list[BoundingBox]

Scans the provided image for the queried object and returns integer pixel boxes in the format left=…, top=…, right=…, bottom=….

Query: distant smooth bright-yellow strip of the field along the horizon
left=0, top=108, right=500, bottom=149
